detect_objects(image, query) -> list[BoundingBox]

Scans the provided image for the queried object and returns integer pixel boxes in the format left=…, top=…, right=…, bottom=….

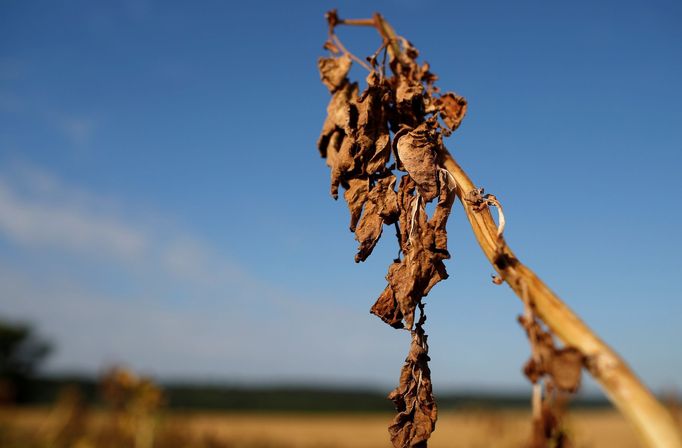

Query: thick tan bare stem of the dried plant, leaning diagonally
left=337, top=13, right=682, bottom=448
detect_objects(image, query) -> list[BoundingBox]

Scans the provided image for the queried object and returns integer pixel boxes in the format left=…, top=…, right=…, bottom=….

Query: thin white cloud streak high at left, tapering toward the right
left=0, top=161, right=257, bottom=298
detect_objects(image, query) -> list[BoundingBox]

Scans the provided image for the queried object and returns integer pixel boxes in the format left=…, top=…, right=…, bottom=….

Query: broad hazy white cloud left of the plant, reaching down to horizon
left=0, top=166, right=407, bottom=382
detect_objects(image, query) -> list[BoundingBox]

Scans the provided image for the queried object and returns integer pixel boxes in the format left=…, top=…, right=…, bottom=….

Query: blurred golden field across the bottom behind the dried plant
left=0, top=408, right=652, bottom=448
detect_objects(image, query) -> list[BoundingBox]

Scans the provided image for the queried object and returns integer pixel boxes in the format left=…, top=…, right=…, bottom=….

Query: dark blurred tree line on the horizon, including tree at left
left=0, top=319, right=609, bottom=413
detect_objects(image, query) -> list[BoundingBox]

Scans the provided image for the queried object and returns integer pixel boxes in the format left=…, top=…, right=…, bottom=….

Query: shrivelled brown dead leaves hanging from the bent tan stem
left=317, top=11, right=581, bottom=447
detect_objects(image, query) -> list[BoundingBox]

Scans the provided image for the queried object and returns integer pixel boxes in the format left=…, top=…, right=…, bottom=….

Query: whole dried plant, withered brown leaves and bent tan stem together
left=318, top=10, right=682, bottom=448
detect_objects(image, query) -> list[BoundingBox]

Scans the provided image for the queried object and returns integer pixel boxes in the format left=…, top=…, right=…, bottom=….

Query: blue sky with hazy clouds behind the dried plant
left=0, top=0, right=682, bottom=391
